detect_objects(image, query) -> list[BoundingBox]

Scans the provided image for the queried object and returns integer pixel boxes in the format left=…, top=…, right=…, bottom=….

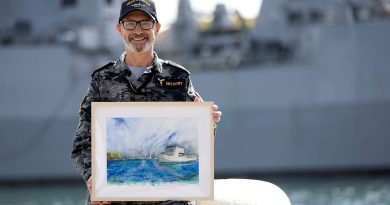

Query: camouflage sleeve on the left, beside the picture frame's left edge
left=71, top=77, right=99, bottom=181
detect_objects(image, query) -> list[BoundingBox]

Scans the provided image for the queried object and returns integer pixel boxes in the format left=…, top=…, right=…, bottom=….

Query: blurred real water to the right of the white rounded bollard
left=279, top=175, right=390, bottom=205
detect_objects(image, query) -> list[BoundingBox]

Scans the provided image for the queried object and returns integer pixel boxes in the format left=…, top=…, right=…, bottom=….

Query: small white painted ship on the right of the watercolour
left=158, top=146, right=198, bottom=163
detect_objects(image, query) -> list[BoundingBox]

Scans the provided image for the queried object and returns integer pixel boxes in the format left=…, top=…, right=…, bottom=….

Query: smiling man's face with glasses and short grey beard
left=116, top=11, right=161, bottom=53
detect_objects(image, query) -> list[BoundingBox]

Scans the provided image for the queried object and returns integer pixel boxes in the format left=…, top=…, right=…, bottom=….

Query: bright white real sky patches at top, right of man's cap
left=155, top=0, right=263, bottom=26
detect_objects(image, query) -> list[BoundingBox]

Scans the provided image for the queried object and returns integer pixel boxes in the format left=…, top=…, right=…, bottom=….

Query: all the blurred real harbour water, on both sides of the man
left=0, top=175, right=390, bottom=205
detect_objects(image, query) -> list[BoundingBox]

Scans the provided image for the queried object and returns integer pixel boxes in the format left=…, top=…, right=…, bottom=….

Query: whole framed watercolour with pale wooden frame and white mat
left=91, top=102, right=214, bottom=201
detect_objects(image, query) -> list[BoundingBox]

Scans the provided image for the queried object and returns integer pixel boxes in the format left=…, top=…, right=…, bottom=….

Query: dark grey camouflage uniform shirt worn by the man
left=71, top=53, right=200, bottom=205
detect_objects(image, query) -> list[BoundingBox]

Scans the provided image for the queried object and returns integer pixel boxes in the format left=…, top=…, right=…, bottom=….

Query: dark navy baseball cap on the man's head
left=119, top=0, right=158, bottom=22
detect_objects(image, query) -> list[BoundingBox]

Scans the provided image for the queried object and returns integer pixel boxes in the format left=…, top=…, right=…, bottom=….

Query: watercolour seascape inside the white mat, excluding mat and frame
left=107, top=117, right=199, bottom=186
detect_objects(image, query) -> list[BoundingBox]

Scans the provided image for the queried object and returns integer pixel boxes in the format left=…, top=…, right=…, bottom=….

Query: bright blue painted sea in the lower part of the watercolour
left=107, top=159, right=199, bottom=185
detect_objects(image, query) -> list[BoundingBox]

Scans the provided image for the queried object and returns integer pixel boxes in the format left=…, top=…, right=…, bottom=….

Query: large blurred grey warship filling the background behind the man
left=0, top=0, right=390, bottom=181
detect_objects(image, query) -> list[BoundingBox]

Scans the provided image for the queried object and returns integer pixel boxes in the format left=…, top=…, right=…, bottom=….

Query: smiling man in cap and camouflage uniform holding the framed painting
left=71, top=0, right=222, bottom=205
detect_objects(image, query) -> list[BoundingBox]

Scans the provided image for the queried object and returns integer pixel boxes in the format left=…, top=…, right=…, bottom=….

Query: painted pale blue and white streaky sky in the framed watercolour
left=107, top=117, right=199, bottom=153
